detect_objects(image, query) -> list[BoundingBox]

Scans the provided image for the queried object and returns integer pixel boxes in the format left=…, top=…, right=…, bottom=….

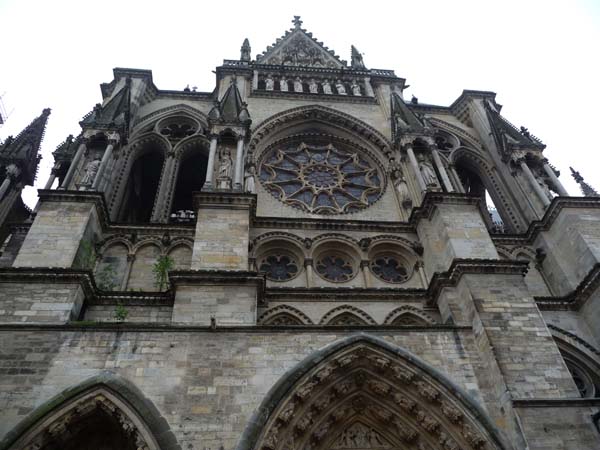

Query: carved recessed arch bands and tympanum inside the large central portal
left=256, top=345, right=505, bottom=450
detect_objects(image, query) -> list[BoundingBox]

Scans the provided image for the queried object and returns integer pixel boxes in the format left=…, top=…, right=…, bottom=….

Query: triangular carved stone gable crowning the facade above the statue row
left=256, top=28, right=345, bottom=69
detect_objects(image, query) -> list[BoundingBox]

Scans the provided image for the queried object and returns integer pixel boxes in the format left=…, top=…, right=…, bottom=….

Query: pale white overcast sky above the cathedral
left=0, top=0, right=600, bottom=206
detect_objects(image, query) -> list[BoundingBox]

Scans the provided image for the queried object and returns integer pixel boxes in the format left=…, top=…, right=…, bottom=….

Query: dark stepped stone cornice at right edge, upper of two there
left=491, top=197, right=600, bottom=245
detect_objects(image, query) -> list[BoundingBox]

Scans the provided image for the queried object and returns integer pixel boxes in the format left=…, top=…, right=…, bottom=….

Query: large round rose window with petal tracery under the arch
left=260, top=144, right=383, bottom=214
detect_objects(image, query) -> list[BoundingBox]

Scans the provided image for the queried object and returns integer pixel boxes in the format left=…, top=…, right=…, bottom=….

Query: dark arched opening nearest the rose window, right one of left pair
left=171, top=151, right=208, bottom=222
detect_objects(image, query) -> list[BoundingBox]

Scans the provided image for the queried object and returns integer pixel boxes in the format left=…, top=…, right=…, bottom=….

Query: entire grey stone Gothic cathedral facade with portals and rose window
left=0, top=17, right=600, bottom=450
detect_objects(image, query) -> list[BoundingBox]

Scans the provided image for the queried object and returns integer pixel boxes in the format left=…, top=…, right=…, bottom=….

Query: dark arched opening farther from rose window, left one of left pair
left=119, top=148, right=164, bottom=223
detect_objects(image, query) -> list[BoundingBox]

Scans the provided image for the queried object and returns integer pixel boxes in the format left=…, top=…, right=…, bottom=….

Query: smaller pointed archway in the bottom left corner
left=0, top=372, right=181, bottom=450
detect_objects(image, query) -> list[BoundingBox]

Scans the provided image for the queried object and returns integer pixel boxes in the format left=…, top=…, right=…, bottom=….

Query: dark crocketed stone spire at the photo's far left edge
left=0, top=108, right=50, bottom=186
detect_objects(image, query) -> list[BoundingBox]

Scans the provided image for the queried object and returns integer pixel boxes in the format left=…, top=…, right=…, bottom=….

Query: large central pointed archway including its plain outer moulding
left=237, top=334, right=512, bottom=450
